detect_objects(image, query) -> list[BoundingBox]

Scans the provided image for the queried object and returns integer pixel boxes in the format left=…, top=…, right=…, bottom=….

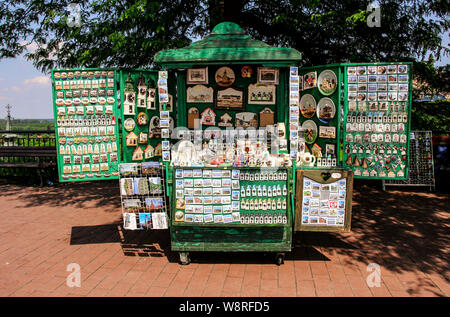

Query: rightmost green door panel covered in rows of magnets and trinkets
left=343, top=63, right=412, bottom=180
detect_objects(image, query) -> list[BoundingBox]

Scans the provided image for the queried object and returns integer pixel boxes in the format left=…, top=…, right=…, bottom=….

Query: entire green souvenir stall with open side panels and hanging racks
left=52, top=22, right=417, bottom=264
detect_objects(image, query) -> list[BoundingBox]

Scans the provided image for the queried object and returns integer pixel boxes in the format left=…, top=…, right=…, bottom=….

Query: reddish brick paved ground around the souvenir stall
left=0, top=182, right=450, bottom=296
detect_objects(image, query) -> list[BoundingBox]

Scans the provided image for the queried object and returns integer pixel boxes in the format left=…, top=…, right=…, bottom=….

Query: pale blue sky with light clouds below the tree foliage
left=0, top=32, right=450, bottom=119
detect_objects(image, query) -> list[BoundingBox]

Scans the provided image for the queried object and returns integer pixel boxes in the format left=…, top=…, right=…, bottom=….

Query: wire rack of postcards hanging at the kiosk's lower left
left=119, top=162, right=168, bottom=230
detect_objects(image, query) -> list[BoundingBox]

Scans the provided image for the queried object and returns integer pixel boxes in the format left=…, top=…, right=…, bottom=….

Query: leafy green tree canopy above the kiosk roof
left=0, top=0, right=449, bottom=72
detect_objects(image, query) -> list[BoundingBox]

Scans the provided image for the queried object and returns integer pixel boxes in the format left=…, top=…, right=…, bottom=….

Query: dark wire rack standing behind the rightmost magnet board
left=383, top=131, right=435, bottom=191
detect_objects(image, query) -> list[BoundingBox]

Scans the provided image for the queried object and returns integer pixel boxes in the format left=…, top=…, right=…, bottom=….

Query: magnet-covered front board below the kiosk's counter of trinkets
left=171, top=167, right=290, bottom=226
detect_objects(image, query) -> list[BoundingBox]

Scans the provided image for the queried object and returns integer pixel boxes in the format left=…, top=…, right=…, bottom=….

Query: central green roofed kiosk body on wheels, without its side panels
left=155, top=22, right=301, bottom=263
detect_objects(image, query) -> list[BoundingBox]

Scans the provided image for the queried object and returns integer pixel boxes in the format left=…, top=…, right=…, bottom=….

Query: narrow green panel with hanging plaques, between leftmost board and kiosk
left=120, top=69, right=176, bottom=163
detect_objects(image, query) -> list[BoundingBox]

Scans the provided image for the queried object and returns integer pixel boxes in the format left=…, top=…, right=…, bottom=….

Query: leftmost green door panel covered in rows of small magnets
left=51, top=68, right=120, bottom=182
